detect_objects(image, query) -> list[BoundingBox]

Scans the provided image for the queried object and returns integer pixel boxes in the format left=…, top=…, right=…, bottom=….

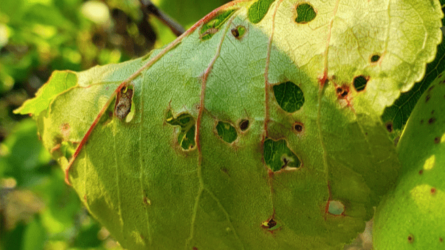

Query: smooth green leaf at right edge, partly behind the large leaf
left=373, top=71, right=445, bottom=250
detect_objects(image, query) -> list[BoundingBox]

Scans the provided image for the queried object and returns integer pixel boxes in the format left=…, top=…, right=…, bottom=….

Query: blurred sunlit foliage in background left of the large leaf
left=0, top=0, right=229, bottom=250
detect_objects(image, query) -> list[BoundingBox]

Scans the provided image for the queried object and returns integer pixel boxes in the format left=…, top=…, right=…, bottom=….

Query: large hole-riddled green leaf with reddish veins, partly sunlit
left=15, top=0, right=443, bottom=249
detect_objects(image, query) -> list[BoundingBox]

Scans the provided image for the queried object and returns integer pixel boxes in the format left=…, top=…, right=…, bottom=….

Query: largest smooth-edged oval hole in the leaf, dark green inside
left=273, top=82, right=304, bottom=113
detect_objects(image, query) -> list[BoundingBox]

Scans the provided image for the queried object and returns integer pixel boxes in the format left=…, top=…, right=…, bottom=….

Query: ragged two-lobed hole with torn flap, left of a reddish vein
left=165, top=110, right=196, bottom=150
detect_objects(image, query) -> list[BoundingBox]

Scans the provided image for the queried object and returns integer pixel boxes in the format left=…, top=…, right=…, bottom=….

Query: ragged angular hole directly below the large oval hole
left=264, top=139, right=301, bottom=172
